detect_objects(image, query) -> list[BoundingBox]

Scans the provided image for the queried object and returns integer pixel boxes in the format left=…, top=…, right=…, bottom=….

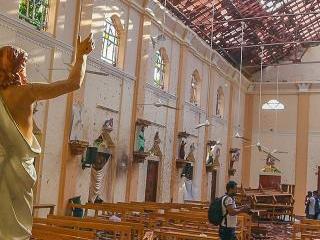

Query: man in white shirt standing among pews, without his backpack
left=219, top=181, right=249, bottom=240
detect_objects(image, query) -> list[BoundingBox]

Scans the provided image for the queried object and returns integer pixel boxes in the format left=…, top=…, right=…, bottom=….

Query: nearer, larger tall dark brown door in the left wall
left=145, top=160, right=159, bottom=202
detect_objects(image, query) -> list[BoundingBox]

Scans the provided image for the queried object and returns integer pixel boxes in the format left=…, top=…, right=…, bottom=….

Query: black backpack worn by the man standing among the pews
left=208, top=195, right=228, bottom=226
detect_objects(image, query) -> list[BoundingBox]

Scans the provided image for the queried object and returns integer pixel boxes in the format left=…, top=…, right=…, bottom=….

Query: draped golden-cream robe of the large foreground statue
left=0, top=94, right=41, bottom=240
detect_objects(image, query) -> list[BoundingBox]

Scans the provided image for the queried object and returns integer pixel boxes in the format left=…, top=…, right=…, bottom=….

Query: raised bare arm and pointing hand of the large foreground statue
left=25, top=34, right=94, bottom=103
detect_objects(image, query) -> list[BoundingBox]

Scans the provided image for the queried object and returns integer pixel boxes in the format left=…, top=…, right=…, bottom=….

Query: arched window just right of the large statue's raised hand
left=101, top=18, right=119, bottom=66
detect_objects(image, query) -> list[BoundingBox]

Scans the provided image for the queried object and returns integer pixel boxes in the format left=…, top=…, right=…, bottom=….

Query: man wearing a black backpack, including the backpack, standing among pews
left=208, top=181, right=249, bottom=240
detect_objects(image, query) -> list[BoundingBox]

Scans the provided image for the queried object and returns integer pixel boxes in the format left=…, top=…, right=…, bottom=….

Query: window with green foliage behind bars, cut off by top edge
left=19, top=0, right=49, bottom=30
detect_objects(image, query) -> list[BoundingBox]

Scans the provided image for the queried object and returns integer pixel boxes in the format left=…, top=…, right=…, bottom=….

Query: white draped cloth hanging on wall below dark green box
left=88, top=167, right=105, bottom=203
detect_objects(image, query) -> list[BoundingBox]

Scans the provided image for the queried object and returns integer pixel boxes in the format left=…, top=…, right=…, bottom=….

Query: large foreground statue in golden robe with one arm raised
left=0, top=35, right=94, bottom=240
